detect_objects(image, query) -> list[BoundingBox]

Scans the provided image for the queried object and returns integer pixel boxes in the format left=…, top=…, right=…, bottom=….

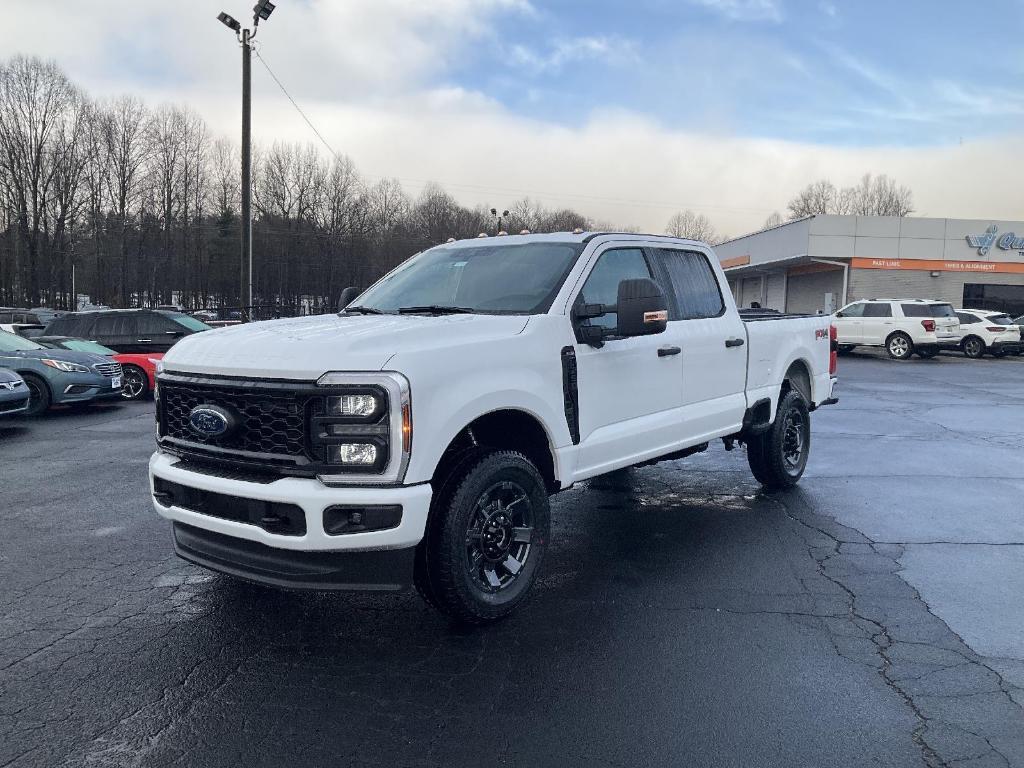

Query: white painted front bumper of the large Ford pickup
left=150, top=452, right=431, bottom=553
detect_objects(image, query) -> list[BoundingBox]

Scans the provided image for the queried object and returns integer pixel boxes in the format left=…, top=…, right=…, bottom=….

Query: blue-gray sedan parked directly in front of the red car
left=0, top=331, right=124, bottom=416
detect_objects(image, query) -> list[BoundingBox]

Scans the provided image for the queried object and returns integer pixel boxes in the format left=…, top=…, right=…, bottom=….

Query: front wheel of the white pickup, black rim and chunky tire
left=417, top=451, right=550, bottom=625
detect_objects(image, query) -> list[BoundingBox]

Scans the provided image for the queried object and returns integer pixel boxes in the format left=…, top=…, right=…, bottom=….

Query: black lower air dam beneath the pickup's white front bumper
left=172, top=522, right=416, bottom=592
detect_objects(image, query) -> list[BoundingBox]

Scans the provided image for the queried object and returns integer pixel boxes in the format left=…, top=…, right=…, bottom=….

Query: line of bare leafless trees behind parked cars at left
left=0, top=56, right=592, bottom=311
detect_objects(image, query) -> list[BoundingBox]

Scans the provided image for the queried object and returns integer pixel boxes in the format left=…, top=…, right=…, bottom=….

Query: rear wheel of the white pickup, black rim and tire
left=746, top=390, right=811, bottom=489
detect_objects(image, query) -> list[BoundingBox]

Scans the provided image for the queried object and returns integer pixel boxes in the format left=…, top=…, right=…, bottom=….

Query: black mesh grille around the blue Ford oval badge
left=160, top=382, right=311, bottom=457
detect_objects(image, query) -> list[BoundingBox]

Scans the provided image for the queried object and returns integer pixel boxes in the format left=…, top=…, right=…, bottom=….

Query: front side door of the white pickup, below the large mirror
left=574, top=246, right=683, bottom=479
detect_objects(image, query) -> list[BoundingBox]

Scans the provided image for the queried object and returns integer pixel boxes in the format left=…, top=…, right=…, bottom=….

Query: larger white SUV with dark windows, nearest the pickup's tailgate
left=836, top=299, right=959, bottom=360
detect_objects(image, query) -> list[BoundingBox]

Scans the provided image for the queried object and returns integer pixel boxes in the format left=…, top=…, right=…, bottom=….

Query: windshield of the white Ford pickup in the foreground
left=355, top=243, right=584, bottom=314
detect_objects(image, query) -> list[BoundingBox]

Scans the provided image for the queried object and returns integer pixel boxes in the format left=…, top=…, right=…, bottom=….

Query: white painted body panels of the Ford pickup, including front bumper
left=150, top=228, right=835, bottom=565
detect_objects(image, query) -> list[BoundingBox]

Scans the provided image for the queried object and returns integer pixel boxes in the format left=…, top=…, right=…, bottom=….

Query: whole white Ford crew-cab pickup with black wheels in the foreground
left=150, top=232, right=836, bottom=623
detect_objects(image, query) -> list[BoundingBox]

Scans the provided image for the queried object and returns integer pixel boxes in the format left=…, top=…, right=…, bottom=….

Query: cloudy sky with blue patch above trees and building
left=0, top=0, right=1024, bottom=234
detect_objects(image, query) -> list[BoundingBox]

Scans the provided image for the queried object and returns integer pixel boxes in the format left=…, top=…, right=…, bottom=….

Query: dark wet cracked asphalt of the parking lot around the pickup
left=0, top=355, right=1024, bottom=768
